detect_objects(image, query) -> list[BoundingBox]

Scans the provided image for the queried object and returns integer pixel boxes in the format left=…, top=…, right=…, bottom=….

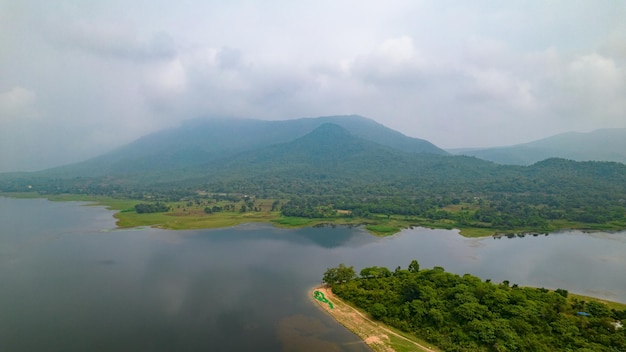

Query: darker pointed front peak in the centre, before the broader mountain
left=146, top=123, right=508, bottom=194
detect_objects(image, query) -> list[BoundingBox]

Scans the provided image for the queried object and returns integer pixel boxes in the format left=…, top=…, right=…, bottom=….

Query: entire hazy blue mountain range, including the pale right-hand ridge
left=0, top=115, right=626, bottom=188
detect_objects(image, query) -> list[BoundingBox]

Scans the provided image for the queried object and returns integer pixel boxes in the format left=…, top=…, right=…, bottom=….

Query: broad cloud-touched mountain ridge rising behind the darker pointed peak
left=44, top=115, right=448, bottom=177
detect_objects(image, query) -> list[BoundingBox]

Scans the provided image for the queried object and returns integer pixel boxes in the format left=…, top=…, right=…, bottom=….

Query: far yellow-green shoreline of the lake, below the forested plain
left=0, top=192, right=626, bottom=238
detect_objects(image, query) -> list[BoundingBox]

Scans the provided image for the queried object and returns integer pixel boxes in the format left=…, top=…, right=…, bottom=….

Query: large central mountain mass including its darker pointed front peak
left=13, top=117, right=502, bottom=194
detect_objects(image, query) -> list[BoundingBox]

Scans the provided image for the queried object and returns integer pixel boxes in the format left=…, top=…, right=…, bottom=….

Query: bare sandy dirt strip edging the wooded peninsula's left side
left=311, top=287, right=436, bottom=352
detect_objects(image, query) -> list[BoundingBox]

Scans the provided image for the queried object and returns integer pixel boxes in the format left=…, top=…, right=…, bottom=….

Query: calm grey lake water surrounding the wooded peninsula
left=0, top=197, right=626, bottom=351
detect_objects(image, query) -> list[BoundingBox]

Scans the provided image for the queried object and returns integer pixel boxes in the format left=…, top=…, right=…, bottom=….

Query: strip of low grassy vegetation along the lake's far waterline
left=3, top=192, right=626, bottom=237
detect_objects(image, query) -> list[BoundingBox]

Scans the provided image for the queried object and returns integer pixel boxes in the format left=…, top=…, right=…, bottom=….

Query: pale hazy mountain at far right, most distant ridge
left=450, top=128, right=626, bottom=165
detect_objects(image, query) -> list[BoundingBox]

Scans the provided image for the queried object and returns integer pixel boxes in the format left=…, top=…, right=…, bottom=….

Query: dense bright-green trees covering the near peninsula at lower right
left=323, top=260, right=626, bottom=351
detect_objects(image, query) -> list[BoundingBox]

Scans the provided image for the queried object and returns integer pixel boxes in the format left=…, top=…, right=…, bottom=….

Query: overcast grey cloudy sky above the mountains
left=0, top=0, right=626, bottom=172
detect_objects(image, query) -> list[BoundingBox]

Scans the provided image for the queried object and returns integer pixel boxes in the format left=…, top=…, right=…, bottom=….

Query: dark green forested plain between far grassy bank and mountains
left=0, top=156, right=626, bottom=232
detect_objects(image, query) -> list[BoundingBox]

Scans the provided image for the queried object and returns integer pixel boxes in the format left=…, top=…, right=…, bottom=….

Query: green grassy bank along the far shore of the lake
left=4, top=192, right=626, bottom=237
